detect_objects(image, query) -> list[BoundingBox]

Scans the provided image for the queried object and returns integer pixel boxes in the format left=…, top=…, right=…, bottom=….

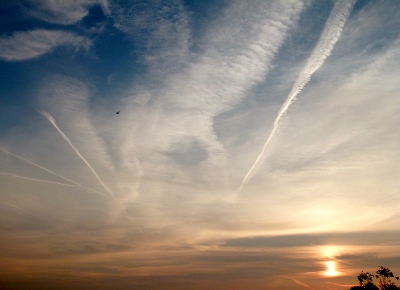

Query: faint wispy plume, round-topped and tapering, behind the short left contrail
left=37, top=75, right=114, bottom=171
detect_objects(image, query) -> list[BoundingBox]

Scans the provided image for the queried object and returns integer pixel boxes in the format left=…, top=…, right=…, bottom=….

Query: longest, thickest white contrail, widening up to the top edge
left=238, top=0, right=356, bottom=191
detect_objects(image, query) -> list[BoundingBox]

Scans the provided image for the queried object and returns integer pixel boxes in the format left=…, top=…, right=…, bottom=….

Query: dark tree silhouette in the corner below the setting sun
left=350, top=266, right=400, bottom=290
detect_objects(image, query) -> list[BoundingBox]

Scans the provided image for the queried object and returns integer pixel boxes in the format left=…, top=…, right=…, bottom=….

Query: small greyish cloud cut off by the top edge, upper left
left=26, top=0, right=109, bottom=25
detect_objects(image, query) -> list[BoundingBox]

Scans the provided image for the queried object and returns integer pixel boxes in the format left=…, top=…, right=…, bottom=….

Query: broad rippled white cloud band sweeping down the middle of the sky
left=115, top=1, right=303, bottom=197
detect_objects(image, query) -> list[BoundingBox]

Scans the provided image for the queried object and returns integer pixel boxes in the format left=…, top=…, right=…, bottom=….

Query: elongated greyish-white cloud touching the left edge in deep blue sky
left=0, top=29, right=92, bottom=61
